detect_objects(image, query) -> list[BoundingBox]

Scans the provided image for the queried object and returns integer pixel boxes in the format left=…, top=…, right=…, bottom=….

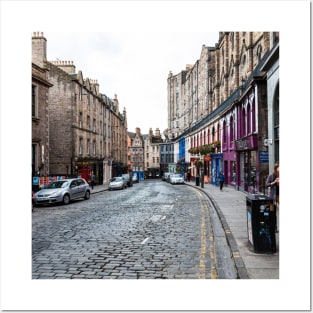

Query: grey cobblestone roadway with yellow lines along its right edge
left=32, top=181, right=236, bottom=279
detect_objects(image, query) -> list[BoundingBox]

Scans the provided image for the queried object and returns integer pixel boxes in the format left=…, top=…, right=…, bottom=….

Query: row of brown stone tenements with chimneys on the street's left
left=32, top=32, right=127, bottom=184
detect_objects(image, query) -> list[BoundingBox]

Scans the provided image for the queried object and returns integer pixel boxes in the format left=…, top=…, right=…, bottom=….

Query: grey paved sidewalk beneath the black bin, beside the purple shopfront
left=186, top=182, right=279, bottom=279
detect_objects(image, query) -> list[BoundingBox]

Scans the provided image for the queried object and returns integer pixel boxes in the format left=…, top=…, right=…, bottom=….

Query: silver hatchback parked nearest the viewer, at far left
left=34, top=178, right=90, bottom=204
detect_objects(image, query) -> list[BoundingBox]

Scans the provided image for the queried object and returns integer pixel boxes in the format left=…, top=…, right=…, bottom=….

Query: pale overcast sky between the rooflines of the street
left=45, top=29, right=218, bottom=133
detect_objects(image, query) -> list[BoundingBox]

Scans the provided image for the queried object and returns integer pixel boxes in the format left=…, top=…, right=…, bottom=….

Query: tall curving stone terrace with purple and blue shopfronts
left=167, top=32, right=279, bottom=192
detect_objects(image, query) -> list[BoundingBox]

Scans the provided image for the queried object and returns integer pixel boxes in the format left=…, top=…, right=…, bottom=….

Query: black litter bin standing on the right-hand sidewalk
left=246, top=195, right=276, bottom=253
